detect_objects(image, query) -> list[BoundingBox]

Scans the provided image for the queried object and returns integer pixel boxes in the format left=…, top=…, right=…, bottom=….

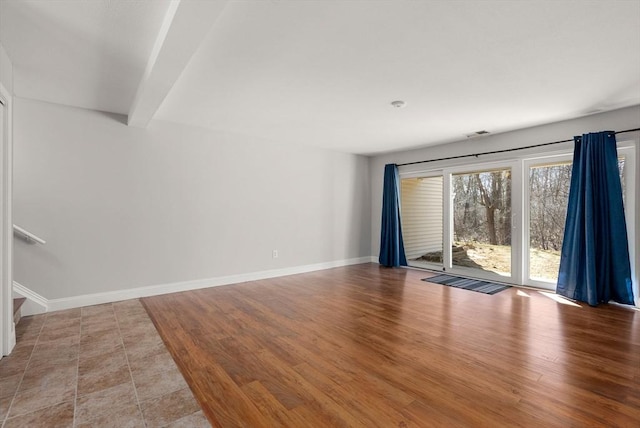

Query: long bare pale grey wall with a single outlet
left=14, top=99, right=371, bottom=299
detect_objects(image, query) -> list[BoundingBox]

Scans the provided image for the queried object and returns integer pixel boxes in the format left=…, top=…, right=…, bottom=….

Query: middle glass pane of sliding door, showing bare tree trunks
left=452, top=169, right=511, bottom=276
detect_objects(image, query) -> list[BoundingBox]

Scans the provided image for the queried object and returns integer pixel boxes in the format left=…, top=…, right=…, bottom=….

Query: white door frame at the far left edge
left=0, top=83, right=16, bottom=358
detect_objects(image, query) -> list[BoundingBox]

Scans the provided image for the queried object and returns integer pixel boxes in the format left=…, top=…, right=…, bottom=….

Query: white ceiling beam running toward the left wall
left=127, top=0, right=228, bottom=128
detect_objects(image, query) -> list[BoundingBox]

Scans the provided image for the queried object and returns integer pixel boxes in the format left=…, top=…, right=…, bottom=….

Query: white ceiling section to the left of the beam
left=0, top=0, right=169, bottom=113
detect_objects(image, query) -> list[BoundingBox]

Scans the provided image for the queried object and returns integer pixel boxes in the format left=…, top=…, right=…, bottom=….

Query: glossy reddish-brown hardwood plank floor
left=143, top=264, right=640, bottom=427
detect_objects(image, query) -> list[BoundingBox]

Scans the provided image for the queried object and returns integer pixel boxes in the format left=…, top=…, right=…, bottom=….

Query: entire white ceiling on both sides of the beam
left=0, top=0, right=640, bottom=154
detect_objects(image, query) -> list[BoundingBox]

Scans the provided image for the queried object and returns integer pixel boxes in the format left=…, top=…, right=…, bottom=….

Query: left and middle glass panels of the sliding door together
left=401, top=165, right=513, bottom=280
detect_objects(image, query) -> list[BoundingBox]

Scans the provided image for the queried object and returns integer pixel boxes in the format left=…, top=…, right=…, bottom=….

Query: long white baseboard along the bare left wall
left=14, top=256, right=377, bottom=312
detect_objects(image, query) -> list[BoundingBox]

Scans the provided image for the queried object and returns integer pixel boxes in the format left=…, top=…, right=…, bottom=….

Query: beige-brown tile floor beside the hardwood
left=0, top=300, right=210, bottom=428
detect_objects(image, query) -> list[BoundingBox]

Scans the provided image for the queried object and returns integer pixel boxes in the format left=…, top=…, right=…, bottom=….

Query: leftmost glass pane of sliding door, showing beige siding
left=401, top=176, right=443, bottom=266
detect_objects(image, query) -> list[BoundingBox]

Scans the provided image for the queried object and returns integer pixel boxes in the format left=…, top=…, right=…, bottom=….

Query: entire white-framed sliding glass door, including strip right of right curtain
left=401, top=145, right=638, bottom=289
